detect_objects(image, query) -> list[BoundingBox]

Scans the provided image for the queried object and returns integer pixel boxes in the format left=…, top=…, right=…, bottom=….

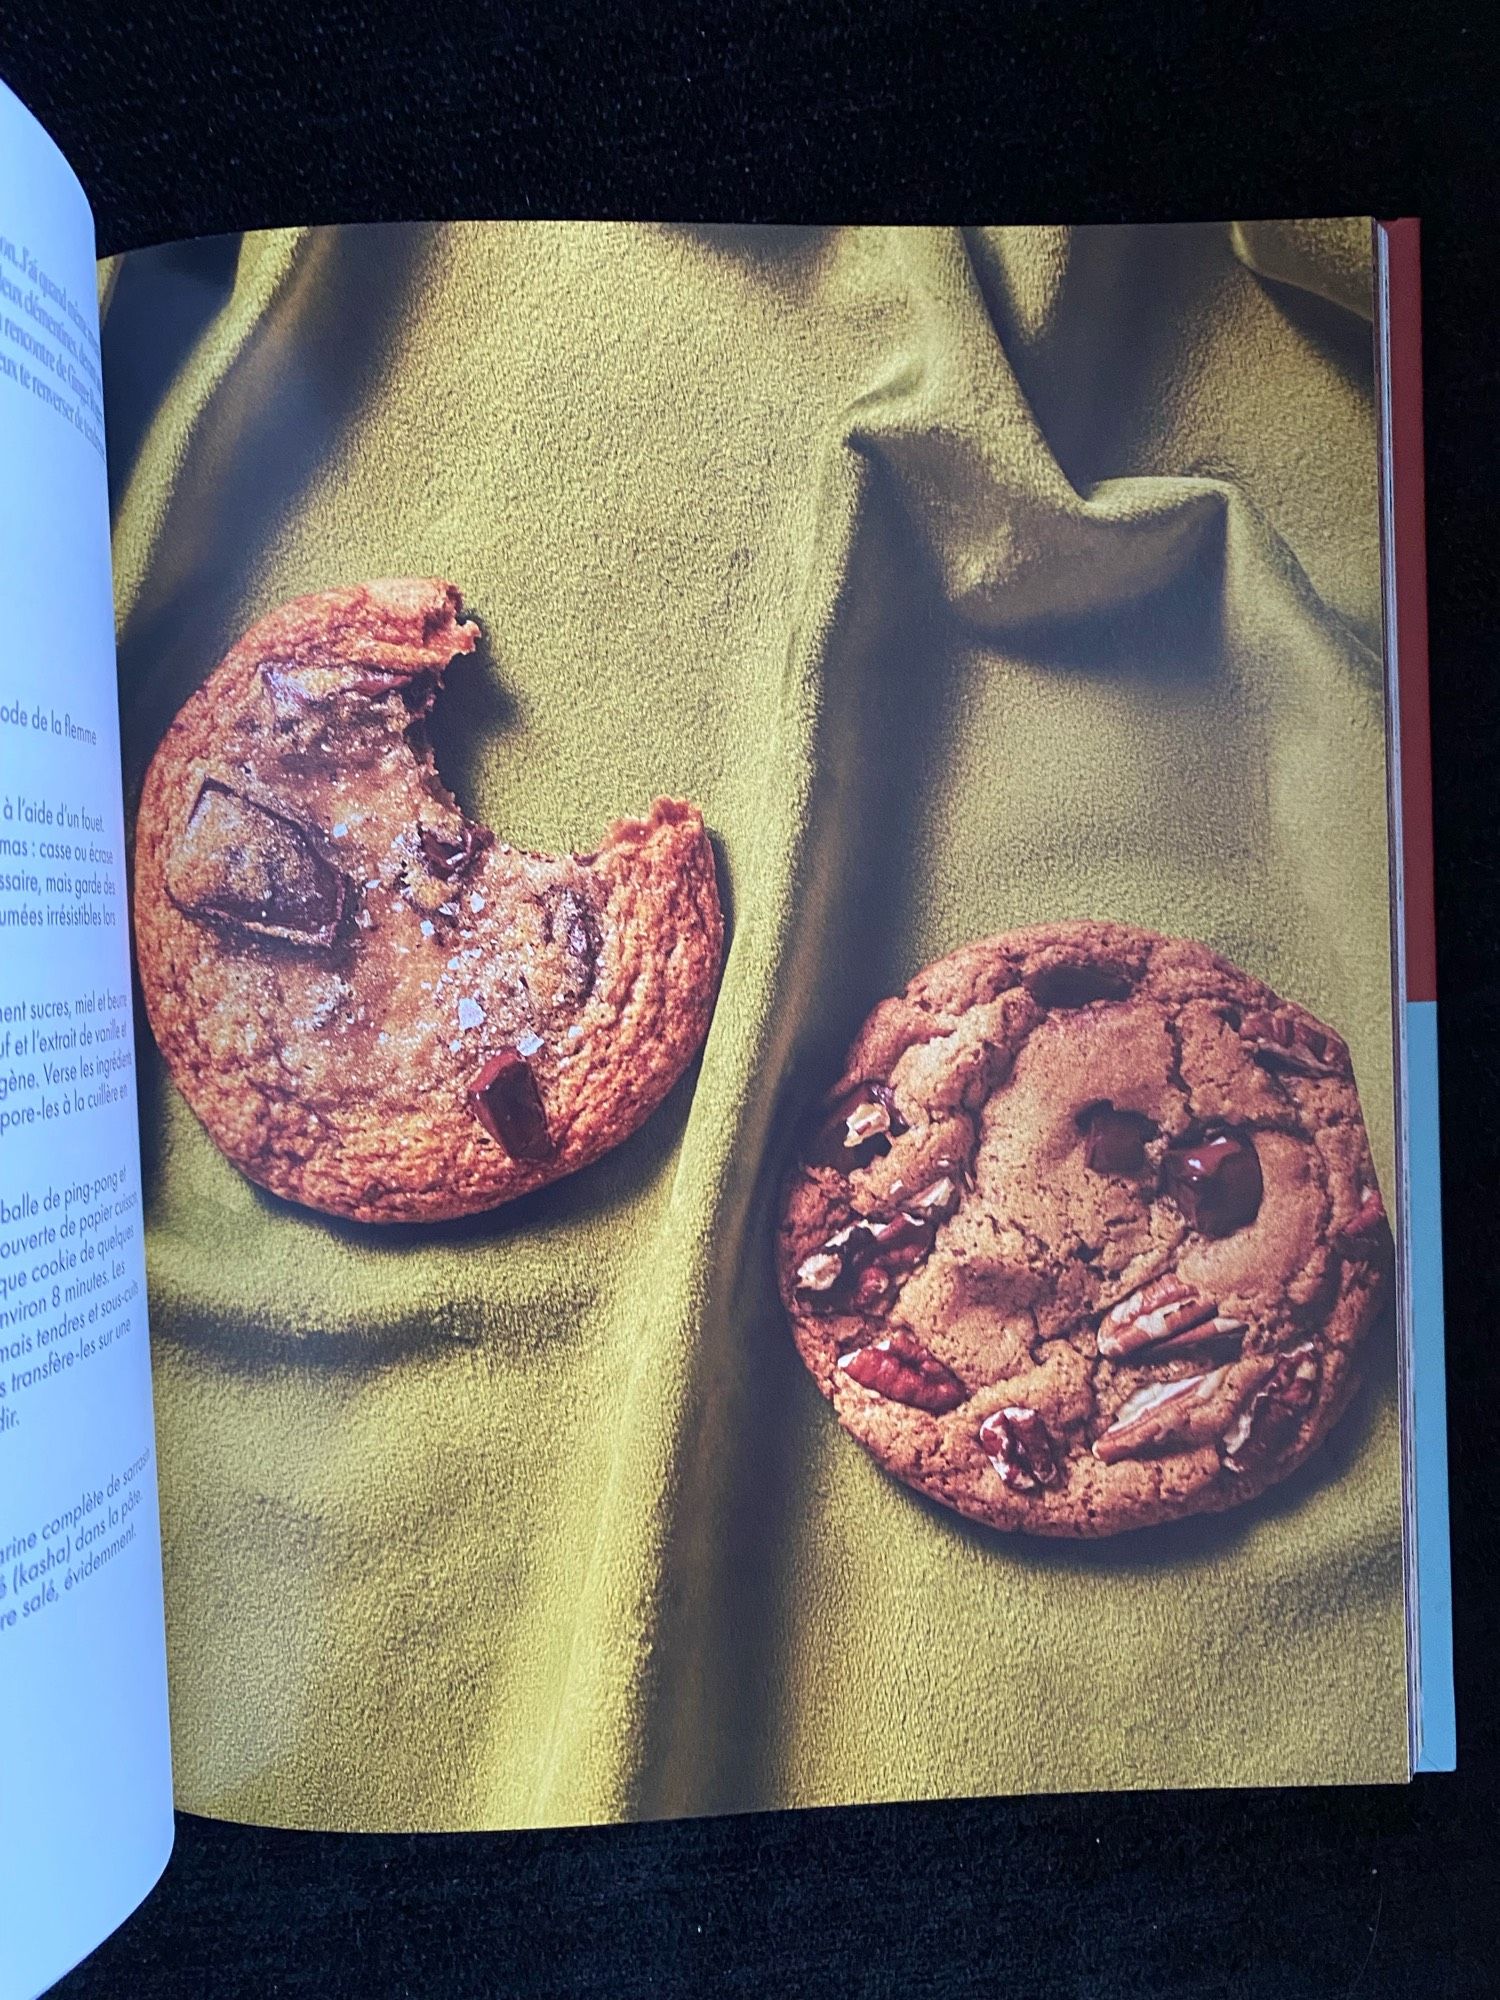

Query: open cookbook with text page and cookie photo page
left=0, top=70, right=1454, bottom=1994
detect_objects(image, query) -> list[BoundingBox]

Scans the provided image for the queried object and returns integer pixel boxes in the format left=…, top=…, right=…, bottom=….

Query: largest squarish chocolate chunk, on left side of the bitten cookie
left=166, top=778, right=348, bottom=950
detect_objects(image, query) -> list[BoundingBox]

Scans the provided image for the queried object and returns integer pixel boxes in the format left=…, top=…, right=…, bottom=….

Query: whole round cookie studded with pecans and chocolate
left=778, top=924, right=1390, bottom=1536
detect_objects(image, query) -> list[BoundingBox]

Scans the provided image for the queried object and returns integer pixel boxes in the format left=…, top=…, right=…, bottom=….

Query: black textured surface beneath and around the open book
left=0, top=0, right=1500, bottom=2000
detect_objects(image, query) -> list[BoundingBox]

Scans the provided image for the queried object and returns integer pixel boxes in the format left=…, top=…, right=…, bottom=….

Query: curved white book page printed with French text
left=0, top=86, right=172, bottom=2000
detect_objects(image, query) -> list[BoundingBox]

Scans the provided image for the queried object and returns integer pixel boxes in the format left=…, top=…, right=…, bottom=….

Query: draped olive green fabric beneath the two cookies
left=106, top=222, right=1406, bottom=1828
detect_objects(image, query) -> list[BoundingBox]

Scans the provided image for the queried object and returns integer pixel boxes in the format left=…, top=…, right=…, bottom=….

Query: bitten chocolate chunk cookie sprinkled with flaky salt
left=134, top=578, right=724, bottom=1222
